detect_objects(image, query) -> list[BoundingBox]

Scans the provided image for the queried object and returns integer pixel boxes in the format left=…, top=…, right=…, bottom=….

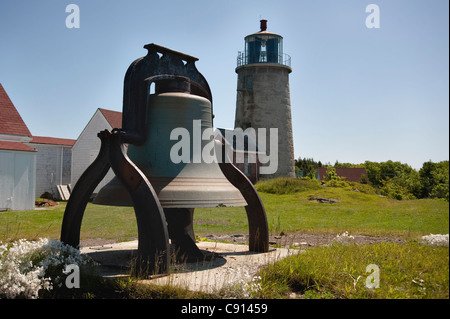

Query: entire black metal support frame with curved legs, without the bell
left=61, top=44, right=269, bottom=274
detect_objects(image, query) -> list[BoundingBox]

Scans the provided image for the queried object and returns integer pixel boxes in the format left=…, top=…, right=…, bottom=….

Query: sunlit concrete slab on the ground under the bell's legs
left=81, top=241, right=301, bottom=292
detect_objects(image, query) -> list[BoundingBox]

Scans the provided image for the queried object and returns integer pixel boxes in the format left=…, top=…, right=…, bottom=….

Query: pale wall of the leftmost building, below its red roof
left=0, top=150, right=36, bottom=210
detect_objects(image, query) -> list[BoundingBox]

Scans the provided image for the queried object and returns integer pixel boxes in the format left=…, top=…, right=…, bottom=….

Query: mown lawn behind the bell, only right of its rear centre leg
left=194, top=187, right=449, bottom=238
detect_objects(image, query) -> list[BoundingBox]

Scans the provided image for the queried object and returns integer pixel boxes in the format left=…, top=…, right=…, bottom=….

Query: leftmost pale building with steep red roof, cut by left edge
left=0, top=84, right=37, bottom=210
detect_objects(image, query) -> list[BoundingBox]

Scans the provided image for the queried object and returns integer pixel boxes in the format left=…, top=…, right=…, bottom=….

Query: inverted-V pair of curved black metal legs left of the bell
left=61, top=129, right=170, bottom=275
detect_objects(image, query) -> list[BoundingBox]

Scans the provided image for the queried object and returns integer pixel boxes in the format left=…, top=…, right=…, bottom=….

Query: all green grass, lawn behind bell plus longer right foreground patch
left=0, top=180, right=449, bottom=298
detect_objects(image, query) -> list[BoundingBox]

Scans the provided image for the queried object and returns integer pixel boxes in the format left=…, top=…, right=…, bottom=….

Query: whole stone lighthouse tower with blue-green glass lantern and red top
left=234, top=20, right=295, bottom=178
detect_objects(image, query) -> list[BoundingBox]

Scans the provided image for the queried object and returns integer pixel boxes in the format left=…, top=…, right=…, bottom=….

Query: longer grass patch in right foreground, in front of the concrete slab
left=255, top=243, right=449, bottom=299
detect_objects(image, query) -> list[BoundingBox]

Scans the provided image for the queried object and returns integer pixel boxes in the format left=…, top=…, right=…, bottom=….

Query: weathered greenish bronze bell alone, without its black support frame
left=94, top=92, right=247, bottom=208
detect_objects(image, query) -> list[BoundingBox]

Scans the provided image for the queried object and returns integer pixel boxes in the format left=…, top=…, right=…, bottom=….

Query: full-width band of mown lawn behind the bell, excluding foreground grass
left=0, top=180, right=449, bottom=241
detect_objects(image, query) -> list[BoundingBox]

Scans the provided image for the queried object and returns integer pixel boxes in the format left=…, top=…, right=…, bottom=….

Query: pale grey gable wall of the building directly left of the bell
left=71, top=110, right=114, bottom=193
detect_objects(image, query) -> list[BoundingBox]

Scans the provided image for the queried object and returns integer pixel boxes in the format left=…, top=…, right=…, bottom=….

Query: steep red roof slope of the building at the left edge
left=0, top=83, right=31, bottom=136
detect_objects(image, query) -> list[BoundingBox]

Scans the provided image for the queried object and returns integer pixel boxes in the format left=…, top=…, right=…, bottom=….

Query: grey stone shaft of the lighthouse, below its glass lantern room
left=235, top=63, right=295, bottom=178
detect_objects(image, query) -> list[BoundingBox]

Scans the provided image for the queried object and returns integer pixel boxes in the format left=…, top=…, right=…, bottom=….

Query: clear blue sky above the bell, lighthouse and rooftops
left=0, top=0, right=449, bottom=169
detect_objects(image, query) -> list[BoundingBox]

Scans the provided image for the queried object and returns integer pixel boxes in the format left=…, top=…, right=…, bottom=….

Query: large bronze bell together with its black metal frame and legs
left=61, top=44, right=268, bottom=273
